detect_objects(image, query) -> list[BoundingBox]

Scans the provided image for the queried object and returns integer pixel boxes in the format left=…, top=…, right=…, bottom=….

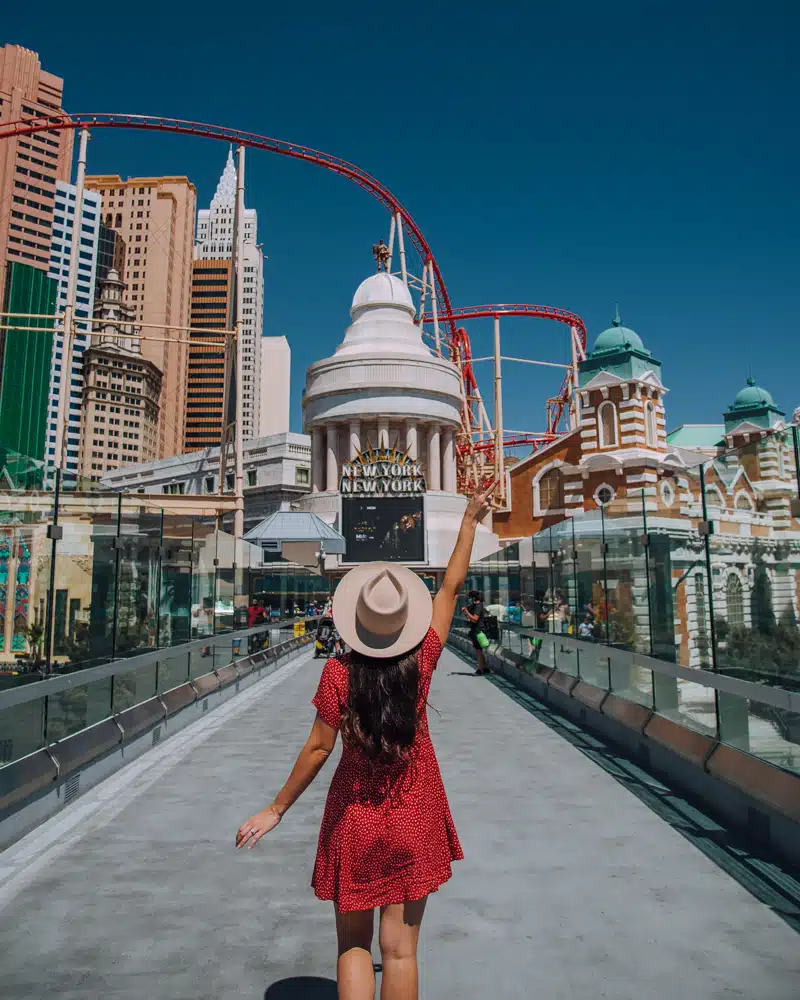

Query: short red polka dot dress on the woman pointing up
left=311, top=629, right=464, bottom=911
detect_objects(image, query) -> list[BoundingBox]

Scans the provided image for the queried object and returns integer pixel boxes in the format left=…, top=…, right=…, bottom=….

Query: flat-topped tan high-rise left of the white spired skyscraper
left=86, top=176, right=197, bottom=458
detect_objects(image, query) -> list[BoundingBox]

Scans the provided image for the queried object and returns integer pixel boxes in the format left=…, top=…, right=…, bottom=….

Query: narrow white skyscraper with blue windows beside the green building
left=45, top=181, right=100, bottom=473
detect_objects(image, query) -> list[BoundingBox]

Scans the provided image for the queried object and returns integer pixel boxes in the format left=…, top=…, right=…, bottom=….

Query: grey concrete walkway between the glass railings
left=0, top=653, right=800, bottom=1000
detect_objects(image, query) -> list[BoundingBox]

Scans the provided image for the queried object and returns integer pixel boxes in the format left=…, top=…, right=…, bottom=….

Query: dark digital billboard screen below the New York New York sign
left=342, top=497, right=425, bottom=563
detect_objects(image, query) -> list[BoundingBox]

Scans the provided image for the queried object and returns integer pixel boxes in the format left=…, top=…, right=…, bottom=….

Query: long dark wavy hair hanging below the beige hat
left=342, top=643, right=422, bottom=764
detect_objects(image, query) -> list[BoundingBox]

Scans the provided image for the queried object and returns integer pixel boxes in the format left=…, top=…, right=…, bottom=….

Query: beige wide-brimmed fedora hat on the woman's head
left=333, top=562, right=433, bottom=659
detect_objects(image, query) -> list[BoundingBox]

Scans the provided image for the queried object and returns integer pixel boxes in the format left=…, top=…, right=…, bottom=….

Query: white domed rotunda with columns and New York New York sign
left=302, top=272, right=496, bottom=569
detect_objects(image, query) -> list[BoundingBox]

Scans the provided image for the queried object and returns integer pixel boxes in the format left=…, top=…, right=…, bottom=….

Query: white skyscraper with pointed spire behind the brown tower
left=192, top=151, right=264, bottom=444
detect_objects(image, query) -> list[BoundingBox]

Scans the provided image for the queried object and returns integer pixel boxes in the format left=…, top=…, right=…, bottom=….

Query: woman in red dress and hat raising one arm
left=236, top=483, right=495, bottom=1000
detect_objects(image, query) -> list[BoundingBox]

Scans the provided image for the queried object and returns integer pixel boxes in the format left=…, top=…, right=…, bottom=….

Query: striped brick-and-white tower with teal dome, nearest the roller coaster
left=579, top=314, right=667, bottom=455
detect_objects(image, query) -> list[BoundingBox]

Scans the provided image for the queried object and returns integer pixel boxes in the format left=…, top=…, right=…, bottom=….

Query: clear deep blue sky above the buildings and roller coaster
left=0, top=0, right=800, bottom=430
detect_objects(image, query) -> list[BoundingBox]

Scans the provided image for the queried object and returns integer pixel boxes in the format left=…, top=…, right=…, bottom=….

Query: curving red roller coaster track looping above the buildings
left=0, top=112, right=586, bottom=480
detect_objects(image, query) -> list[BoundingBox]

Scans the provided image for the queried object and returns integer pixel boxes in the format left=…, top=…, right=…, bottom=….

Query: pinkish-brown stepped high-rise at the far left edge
left=0, top=45, right=72, bottom=302
